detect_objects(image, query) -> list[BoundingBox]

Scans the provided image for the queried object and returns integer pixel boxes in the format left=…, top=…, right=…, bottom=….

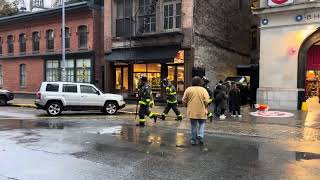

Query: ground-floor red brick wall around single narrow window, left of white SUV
left=0, top=57, right=44, bottom=92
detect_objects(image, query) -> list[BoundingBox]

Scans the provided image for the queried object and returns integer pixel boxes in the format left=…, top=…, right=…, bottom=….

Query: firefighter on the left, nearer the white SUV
left=137, top=76, right=157, bottom=127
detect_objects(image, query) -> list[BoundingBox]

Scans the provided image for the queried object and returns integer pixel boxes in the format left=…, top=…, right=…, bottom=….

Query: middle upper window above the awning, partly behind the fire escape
left=139, top=0, right=156, bottom=33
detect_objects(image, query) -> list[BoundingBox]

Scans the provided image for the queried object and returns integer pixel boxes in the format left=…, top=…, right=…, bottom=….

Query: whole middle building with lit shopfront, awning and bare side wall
left=104, top=0, right=252, bottom=96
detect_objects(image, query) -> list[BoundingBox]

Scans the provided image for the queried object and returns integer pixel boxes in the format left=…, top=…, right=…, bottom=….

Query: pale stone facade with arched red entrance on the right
left=253, top=0, right=320, bottom=110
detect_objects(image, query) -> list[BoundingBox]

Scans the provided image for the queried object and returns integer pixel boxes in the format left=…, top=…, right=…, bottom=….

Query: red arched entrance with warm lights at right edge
left=306, top=44, right=320, bottom=111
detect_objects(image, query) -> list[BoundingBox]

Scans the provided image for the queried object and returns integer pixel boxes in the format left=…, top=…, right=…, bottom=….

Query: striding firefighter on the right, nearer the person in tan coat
left=161, top=78, right=182, bottom=121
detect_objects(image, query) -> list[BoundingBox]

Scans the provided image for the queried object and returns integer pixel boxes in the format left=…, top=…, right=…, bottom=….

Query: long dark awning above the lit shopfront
left=105, top=45, right=180, bottom=63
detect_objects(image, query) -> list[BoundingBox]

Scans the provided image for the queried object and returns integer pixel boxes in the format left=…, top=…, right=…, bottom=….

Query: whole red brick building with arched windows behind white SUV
left=0, top=2, right=105, bottom=93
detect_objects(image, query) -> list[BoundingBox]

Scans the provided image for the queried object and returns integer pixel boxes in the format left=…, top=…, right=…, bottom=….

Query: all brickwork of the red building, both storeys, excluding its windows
left=0, top=9, right=104, bottom=92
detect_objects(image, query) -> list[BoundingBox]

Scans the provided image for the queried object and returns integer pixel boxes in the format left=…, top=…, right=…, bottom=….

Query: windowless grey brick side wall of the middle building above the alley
left=192, top=0, right=255, bottom=83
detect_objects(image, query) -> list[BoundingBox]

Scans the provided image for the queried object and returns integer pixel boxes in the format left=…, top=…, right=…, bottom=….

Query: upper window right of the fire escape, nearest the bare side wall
left=163, top=0, right=181, bottom=30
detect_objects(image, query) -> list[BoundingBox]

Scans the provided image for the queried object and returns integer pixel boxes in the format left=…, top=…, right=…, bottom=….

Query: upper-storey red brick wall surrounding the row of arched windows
left=0, top=11, right=94, bottom=57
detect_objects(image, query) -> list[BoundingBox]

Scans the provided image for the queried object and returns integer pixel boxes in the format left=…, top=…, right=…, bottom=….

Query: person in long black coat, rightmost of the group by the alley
left=229, top=83, right=242, bottom=118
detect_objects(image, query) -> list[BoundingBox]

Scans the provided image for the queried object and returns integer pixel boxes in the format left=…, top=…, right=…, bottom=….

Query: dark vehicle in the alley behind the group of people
left=225, top=76, right=250, bottom=104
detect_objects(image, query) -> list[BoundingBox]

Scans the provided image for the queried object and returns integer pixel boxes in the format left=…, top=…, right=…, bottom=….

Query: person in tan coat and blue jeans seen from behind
left=182, top=76, right=209, bottom=145
